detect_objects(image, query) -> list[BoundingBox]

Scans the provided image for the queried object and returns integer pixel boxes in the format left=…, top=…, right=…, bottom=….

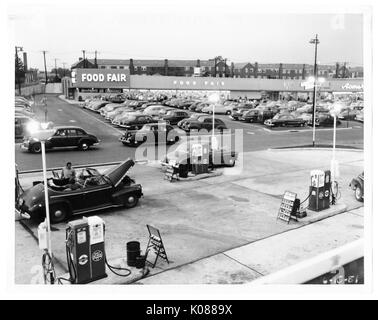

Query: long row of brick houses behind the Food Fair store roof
left=71, top=57, right=363, bottom=80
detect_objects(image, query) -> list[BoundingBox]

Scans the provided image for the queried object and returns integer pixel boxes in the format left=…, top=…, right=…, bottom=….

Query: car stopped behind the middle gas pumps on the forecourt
left=161, top=140, right=238, bottom=177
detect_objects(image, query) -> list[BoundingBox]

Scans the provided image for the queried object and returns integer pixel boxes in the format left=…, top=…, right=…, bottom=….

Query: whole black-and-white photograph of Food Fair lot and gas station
left=3, top=1, right=373, bottom=300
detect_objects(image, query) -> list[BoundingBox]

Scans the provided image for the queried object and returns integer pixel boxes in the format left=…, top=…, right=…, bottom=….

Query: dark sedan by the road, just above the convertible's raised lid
left=119, top=123, right=180, bottom=147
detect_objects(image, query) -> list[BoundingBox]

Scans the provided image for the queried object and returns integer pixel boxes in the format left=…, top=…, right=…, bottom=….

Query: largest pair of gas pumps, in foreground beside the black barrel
left=66, top=216, right=107, bottom=284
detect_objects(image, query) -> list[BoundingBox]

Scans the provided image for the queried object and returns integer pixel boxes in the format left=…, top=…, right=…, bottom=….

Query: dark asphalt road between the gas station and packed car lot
left=15, top=95, right=363, bottom=171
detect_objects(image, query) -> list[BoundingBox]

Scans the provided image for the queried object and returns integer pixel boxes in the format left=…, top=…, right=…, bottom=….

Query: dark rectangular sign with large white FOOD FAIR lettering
left=72, top=69, right=130, bottom=88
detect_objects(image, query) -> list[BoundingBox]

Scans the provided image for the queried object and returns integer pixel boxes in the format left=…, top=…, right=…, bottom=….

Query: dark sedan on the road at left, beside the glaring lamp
left=21, top=126, right=100, bottom=153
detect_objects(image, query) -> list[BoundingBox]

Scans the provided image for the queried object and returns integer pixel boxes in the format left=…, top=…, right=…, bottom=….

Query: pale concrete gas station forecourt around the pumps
left=16, top=150, right=363, bottom=281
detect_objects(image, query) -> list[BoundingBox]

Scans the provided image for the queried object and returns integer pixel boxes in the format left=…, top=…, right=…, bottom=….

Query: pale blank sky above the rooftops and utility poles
left=8, top=0, right=363, bottom=70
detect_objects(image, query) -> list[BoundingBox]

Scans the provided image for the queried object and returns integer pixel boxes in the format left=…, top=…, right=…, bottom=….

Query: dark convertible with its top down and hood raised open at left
left=16, top=159, right=143, bottom=223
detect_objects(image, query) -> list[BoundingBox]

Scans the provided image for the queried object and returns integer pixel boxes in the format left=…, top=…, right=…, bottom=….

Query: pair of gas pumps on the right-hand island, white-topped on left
left=308, top=170, right=331, bottom=211
